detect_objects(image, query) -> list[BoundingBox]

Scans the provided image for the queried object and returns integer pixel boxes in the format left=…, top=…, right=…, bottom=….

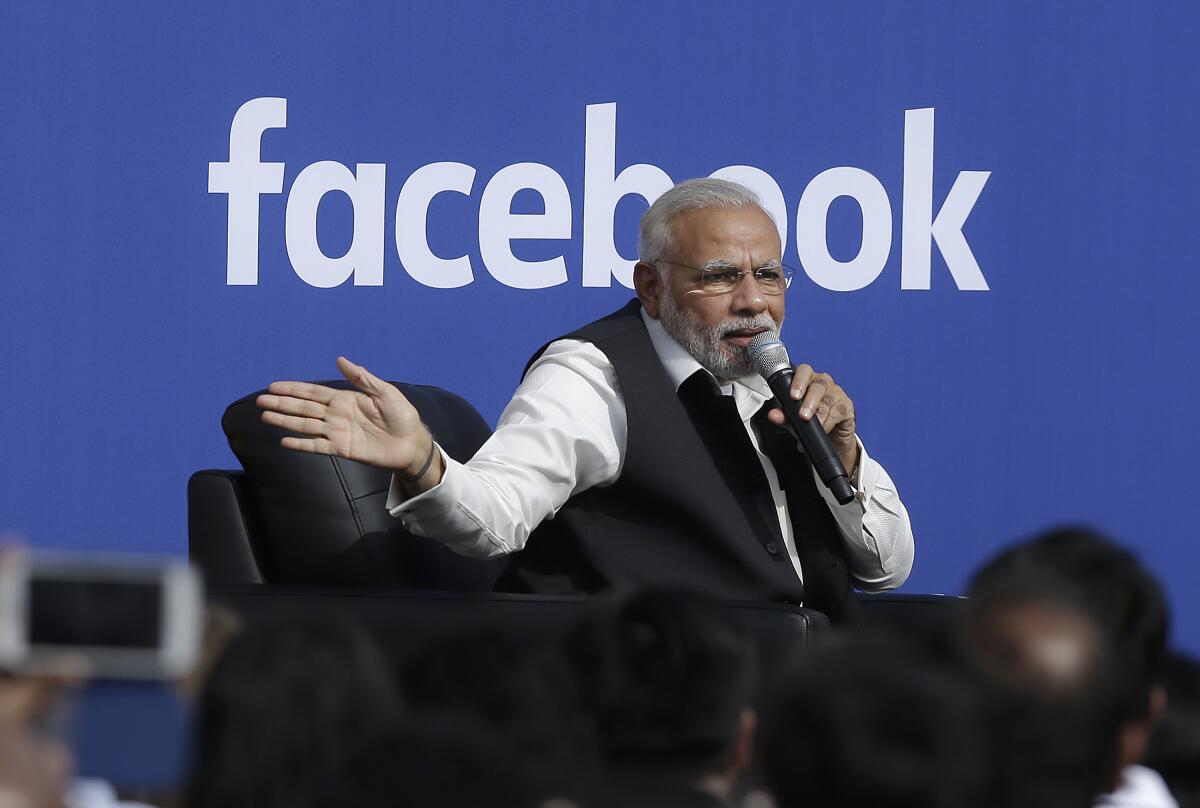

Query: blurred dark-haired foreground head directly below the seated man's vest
left=569, top=591, right=756, bottom=804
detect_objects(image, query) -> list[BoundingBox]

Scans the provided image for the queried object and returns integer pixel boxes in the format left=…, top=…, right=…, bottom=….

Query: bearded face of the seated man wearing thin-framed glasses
left=635, top=208, right=784, bottom=382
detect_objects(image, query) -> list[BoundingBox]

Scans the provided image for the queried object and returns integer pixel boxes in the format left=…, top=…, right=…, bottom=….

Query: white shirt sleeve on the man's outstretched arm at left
left=388, top=340, right=628, bottom=557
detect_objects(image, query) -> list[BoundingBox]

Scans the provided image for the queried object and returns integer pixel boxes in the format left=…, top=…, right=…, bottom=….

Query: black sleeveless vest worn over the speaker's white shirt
left=500, top=300, right=858, bottom=621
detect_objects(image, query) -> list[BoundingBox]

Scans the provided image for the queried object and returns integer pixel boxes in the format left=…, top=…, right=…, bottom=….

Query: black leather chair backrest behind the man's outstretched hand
left=208, top=382, right=499, bottom=591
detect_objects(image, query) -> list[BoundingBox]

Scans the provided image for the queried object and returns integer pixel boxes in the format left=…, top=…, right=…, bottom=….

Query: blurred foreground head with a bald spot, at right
left=959, top=528, right=1166, bottom=806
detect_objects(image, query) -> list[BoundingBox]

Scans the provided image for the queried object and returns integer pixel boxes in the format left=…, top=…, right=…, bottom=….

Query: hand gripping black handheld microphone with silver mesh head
left=746, top=331, right=857, bottom=505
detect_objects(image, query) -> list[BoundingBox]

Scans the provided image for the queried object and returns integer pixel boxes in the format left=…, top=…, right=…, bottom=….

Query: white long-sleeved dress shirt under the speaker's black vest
left=388, top=310, right=913, bottom=591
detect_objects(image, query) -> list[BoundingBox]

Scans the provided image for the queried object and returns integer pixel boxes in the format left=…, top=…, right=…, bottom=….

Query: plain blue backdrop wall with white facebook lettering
left=0, top=0, right=1200, bottom=651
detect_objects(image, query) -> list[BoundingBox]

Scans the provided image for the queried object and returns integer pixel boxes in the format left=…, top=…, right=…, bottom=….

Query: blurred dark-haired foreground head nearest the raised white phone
left=184, top=617, right=398, bottom=808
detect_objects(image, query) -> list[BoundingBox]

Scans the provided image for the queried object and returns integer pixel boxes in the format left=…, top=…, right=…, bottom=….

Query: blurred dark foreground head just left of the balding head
left=758, top=635, right=985, bottom=808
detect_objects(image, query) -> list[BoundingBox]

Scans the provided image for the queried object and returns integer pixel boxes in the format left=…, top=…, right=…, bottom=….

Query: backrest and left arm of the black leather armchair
left=187, top=382, right=499, bottom=591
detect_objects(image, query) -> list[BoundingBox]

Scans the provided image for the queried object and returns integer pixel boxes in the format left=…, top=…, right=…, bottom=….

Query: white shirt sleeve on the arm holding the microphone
left=814, top=441, right=914, bottom=592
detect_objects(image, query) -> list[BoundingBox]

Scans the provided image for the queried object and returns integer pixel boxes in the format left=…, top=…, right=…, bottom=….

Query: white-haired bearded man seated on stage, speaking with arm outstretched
left=259, top=179, right=912, bottom=620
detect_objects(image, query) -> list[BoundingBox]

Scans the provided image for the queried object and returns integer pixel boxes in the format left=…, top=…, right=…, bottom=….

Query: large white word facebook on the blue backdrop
left=209, top=98, right=991, bottom=292
